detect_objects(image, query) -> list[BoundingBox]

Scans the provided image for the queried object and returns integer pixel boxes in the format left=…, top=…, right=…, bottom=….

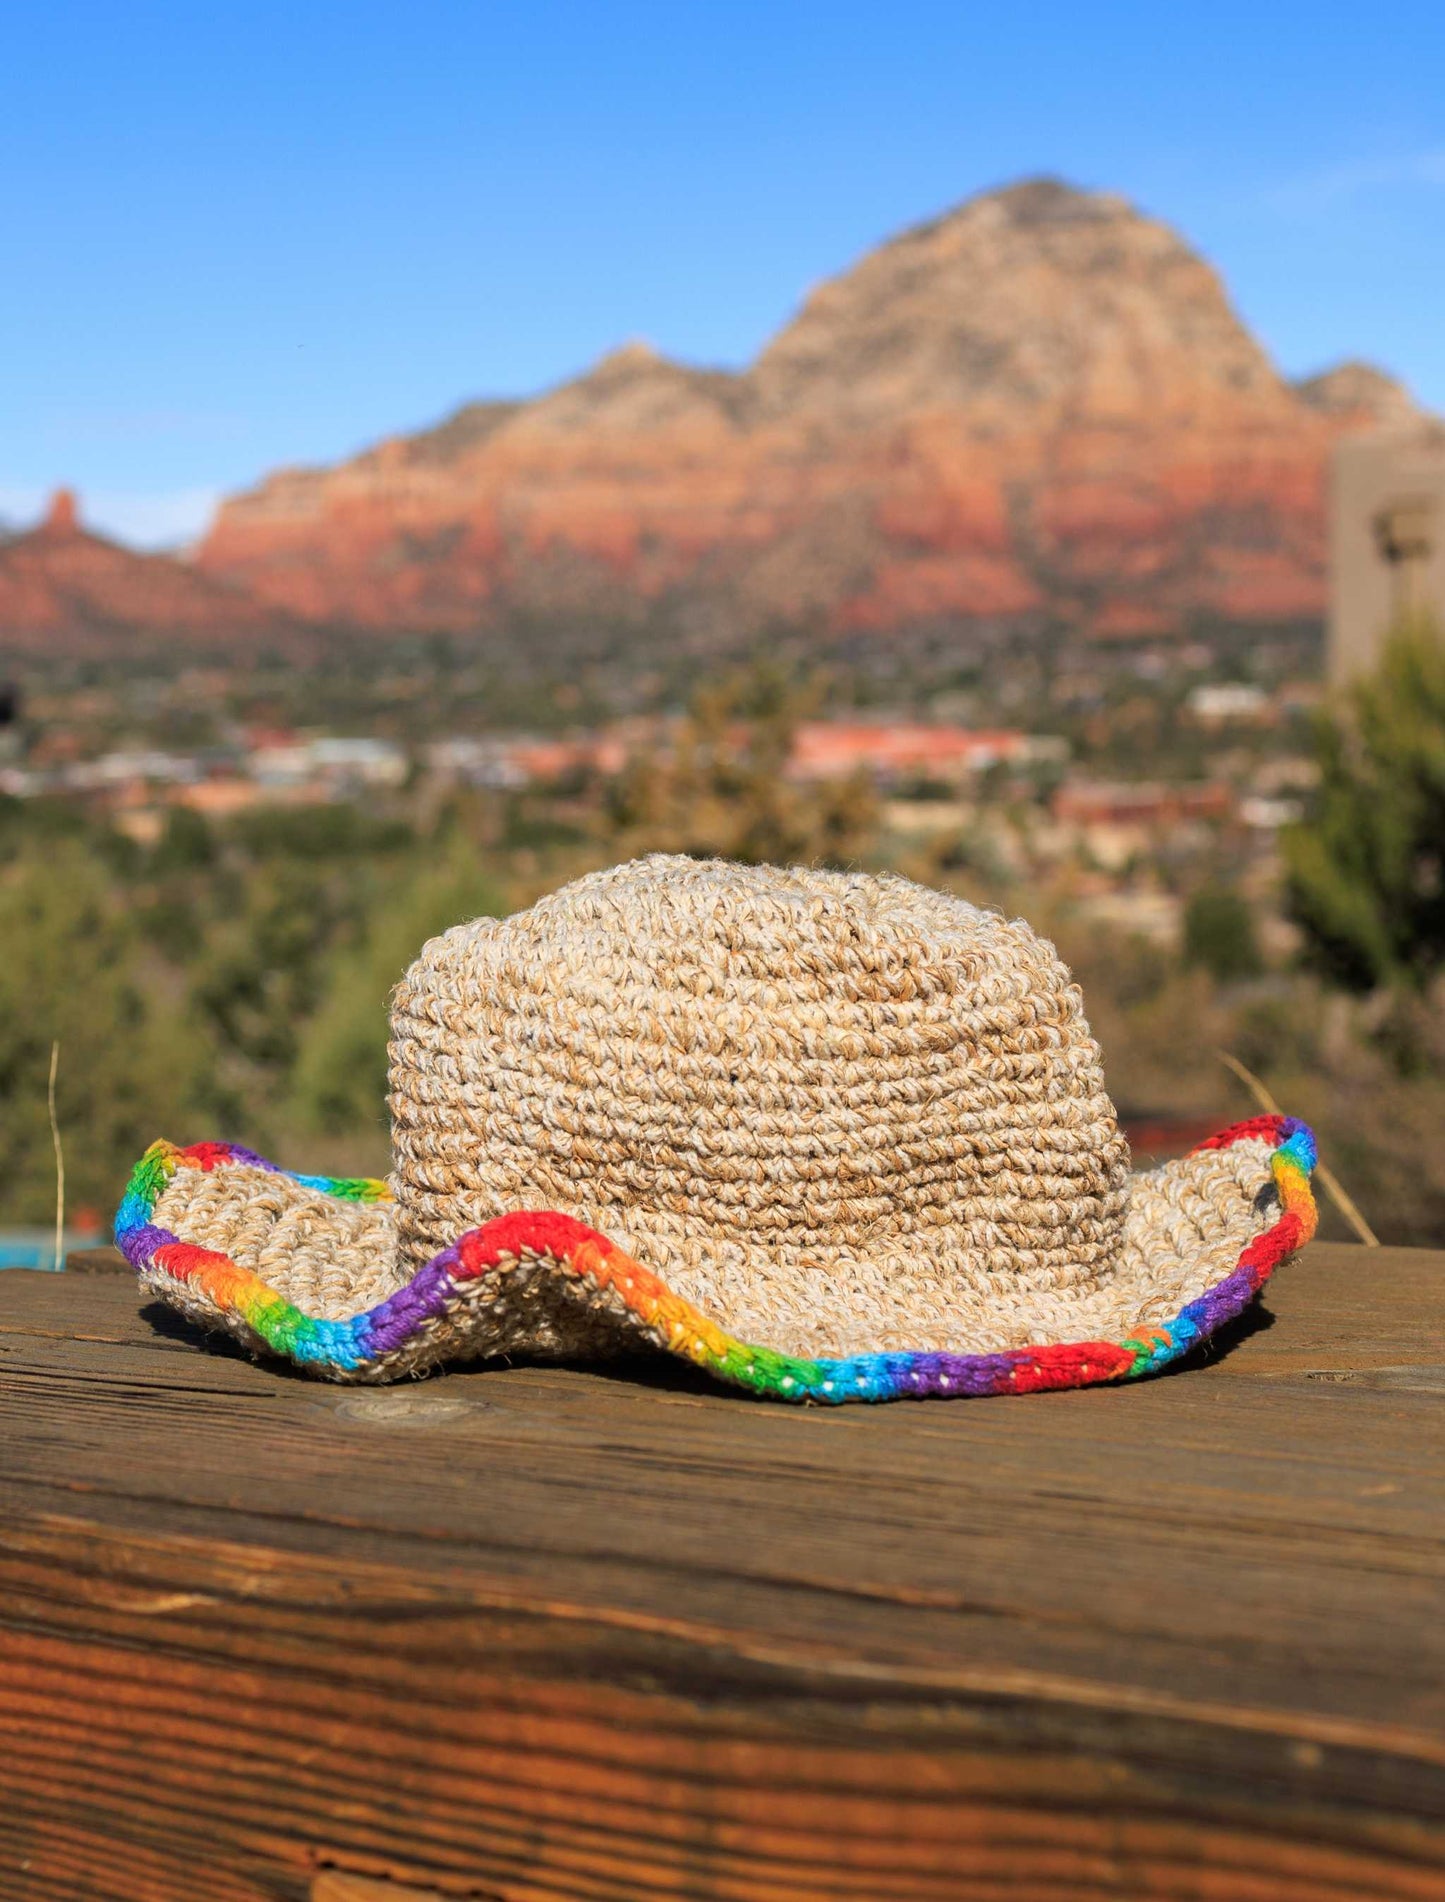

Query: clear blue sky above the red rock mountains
left=0, top=0, right=1445, bottom=544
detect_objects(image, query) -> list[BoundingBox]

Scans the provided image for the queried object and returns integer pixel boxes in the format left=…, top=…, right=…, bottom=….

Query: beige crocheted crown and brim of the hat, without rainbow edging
left=156, top=858, right=1274, bottom=1358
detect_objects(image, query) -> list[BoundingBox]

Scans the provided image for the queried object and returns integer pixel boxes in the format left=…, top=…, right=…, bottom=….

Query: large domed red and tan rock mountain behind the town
left=200, top=181, right=1409, bottom=635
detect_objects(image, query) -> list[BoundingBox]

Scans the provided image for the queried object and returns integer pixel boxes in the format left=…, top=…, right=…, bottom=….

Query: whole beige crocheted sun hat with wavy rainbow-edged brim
left=116, top=858, right=1314, bottom=1402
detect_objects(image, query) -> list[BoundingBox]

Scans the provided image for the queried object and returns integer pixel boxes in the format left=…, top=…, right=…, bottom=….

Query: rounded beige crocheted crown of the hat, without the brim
left=390, top=858, right=1127, bottom=1323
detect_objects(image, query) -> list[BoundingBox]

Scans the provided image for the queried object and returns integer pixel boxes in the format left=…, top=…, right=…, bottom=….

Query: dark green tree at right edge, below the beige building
left=1283, top=622, right=1445, bottom=991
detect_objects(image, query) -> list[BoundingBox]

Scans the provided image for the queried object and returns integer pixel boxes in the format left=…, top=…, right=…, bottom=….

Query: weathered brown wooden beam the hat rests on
left=0, top=1246, right=1445, bottom=1902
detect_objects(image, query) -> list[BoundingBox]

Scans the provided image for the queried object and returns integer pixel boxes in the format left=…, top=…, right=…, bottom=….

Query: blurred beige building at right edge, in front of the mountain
left=1329, top=422, right=1445, bottom=685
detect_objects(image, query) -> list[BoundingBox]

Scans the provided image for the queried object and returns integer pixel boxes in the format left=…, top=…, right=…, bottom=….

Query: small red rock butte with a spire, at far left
left=0, top=489, right=310, bottom=654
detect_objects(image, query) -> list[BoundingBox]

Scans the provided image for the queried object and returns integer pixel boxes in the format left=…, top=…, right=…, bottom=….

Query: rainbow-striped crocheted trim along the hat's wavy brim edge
left=116, top=1116, right=1316, bottom=1406
